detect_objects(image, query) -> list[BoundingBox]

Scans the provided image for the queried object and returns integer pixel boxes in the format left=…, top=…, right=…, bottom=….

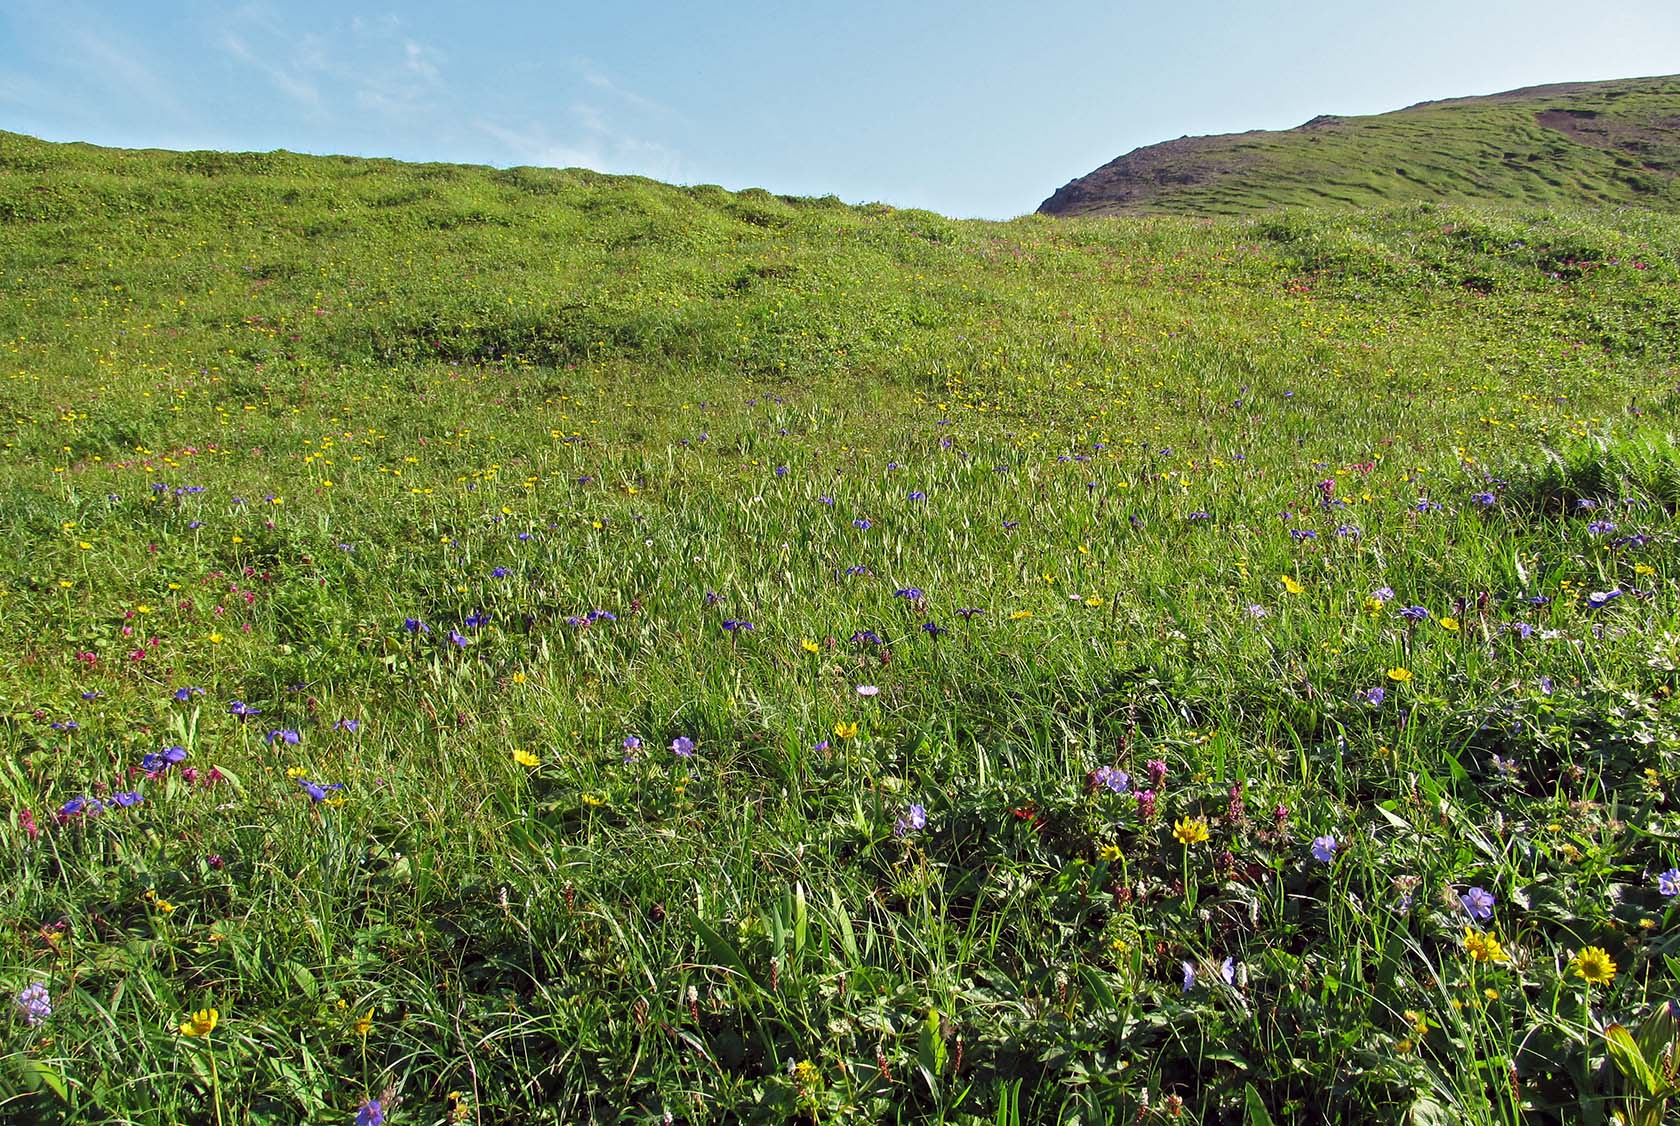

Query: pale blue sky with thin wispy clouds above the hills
left=0, top=0, right=1680, bottom=218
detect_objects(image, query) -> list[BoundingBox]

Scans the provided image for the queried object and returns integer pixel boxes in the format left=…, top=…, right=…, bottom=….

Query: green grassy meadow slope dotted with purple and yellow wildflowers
left=0, top=127, right=1680, bottom=1126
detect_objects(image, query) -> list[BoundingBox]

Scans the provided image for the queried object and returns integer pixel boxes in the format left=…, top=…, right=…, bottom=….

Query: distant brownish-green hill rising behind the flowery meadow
left=1038, top=76, right=1680, bottom=215
